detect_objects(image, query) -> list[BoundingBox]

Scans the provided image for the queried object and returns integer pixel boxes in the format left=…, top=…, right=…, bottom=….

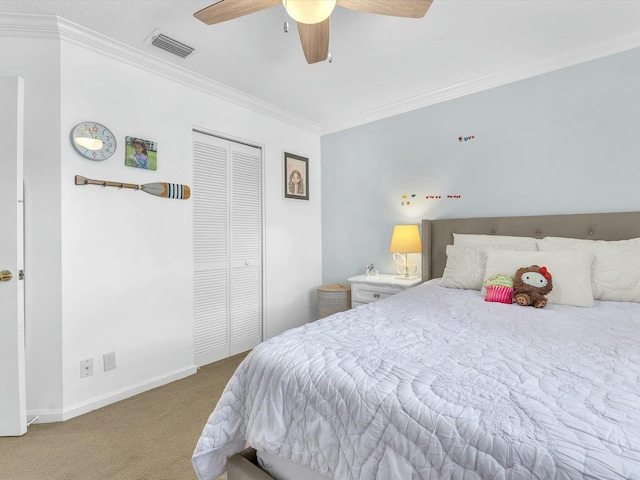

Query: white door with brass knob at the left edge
left=0, top=77, right=27, bottom=436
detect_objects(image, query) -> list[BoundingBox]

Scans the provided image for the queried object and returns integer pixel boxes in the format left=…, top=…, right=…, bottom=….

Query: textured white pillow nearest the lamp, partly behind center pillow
left=440, top=243, right=531, bottom=290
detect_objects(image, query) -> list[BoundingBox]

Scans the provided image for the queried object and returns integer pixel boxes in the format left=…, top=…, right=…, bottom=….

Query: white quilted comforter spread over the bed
left=193, top=280, right=640, bottom=480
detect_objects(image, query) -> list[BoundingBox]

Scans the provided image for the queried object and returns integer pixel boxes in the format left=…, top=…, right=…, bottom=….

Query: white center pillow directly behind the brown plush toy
left=484, top=249, right=593, bottom=307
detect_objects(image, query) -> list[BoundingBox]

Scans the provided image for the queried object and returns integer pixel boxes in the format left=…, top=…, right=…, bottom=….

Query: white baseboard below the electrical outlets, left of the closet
left=27, top=365, right=198, bottom=423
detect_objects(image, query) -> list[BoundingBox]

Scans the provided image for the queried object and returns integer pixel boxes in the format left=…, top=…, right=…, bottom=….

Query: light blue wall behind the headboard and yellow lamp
left=322, top=49, right=640, bottom=284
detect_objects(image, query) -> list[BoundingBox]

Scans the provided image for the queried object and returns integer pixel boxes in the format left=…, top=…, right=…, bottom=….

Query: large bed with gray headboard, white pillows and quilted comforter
left=192, top=212, right=640, bottom=480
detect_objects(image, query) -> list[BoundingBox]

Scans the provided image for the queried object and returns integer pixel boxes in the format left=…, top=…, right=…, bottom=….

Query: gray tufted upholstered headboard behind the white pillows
left=422, top=212, right=640, bottom=281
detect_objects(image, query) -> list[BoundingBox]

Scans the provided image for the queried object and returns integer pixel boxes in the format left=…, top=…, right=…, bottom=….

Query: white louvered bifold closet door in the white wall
left=192, top=132, right=262, bottom=365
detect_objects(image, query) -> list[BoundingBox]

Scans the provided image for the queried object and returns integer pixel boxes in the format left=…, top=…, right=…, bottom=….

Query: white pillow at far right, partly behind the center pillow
left=538, top=237, right=640, bottom=303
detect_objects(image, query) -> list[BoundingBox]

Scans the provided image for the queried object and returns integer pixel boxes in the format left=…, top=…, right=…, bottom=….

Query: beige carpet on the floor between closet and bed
left=0, top=354, right=245, bottom=480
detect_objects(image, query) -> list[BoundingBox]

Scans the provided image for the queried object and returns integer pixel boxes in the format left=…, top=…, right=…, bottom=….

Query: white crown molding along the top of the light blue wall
left=321, top=30, right=640, bottom=135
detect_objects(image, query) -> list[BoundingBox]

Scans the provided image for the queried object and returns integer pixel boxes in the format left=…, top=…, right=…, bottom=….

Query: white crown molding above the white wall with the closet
left=0, top=14, right=321, bottom=135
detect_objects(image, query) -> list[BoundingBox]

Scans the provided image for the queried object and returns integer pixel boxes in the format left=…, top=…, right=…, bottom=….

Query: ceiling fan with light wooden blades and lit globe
left=193, top=0, right=433, bottom=63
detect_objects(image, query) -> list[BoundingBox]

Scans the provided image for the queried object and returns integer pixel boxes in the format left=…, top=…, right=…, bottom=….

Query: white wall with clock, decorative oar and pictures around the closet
left=0, top=14, right=321, bottom=420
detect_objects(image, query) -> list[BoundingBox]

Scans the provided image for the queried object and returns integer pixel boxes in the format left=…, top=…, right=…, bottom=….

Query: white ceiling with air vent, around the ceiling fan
left=0, top=0, right=640, bottom=133
